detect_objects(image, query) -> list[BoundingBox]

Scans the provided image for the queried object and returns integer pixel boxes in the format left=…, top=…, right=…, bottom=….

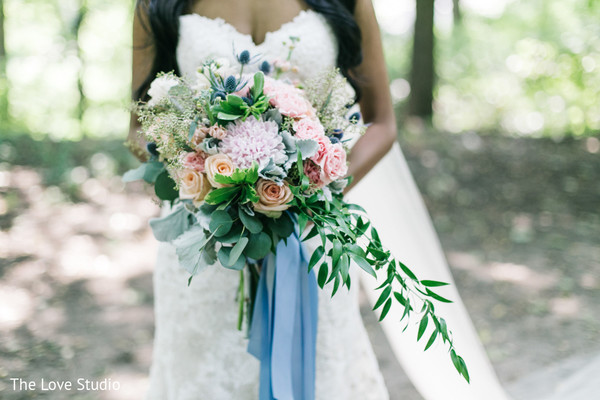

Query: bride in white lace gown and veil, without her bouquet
left=130, top=0, right=508, bottom=400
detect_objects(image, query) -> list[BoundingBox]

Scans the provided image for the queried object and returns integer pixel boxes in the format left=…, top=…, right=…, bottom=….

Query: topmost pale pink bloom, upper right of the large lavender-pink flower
left=263, top=77, right=312, bottom=118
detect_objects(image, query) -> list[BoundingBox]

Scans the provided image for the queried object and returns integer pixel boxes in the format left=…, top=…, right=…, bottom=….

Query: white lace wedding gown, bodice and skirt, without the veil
left=147, top=11, right=389, bottom=400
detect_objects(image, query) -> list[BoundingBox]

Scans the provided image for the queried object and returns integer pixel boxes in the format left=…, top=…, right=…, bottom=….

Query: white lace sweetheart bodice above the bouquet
left=177, top=10, right=337, bottom=80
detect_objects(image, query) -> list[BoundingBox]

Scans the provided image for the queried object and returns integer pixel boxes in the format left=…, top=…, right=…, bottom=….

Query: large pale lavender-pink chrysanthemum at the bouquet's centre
left=219, top=117, right=287, bottom=169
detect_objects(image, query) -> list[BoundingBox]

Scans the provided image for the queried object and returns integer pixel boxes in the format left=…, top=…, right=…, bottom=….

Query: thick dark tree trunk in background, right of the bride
left=409, top=0, right=435, bottom=117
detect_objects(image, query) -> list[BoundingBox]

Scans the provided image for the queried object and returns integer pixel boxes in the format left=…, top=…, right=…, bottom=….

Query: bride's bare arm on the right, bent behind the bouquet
left=348, top=0, right=397, bottom=189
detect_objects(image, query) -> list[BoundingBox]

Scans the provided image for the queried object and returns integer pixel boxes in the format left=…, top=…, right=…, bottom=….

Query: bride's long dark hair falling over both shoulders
left=135, top=0, right=362, bottom=99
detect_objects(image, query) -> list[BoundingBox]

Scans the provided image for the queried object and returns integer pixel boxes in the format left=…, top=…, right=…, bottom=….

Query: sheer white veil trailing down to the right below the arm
left=348, top=143, right=509, bottom=400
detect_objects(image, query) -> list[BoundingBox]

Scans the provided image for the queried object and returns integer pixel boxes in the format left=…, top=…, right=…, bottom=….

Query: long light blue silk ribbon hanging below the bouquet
left=248, top=228, right=318, bottom=400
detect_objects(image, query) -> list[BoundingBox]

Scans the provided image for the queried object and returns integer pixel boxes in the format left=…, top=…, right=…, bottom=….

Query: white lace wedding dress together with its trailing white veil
left=147, top=7, right=505, bottom=400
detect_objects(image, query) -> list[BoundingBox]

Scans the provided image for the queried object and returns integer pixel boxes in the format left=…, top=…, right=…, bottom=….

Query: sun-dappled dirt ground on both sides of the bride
left=0, top=132, right=600, bottom=400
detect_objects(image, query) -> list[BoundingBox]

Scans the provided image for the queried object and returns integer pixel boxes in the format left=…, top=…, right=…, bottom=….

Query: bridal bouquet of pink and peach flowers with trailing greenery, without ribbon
left=124, top=51, right=469, bottom=380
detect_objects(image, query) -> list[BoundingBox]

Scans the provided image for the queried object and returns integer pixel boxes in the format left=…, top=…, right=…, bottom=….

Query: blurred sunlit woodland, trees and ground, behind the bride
left=0, top=0, right=600, bottom=400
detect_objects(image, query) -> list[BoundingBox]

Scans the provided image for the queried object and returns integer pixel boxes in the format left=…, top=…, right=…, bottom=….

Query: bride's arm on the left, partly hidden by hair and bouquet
left=127, top=7, right=154, bottom=161
